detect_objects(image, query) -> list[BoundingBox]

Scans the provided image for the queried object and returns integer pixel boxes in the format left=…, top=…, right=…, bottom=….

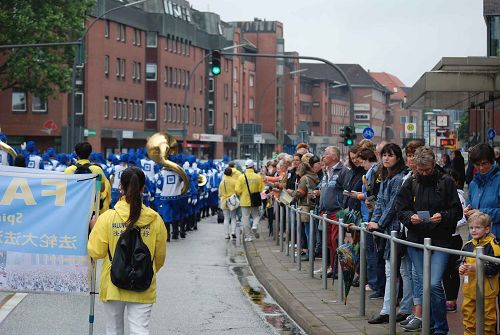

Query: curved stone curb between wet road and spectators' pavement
left=243, top=242, right=335, bottom=335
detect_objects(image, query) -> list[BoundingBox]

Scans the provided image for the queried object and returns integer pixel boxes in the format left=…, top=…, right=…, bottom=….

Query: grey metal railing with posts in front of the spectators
left=273, top=201, right=500, bottom=335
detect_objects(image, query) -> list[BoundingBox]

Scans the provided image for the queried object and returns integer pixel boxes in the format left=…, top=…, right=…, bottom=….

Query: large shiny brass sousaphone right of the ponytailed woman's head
left=146, top=132, right=189, bottom=194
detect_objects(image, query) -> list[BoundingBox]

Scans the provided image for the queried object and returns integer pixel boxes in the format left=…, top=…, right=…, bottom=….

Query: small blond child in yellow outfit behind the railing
left=458, top=212, right=500, bottom=335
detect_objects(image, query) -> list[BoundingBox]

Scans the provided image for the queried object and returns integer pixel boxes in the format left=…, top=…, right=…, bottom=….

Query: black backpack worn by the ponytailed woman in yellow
left=108, top=215, right=154, bottom=292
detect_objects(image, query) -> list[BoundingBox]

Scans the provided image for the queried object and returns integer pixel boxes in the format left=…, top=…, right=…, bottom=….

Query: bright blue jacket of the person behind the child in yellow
left=467, top=163, right=500, bottom=238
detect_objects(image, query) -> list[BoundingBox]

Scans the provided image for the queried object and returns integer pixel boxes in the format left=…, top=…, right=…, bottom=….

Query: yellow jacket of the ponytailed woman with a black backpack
left=87, top=197, right=167, bottom=304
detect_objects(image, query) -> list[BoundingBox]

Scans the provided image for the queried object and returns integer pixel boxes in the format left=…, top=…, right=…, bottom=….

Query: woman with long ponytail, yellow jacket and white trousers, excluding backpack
left=87, top=167, right=167, bottom=335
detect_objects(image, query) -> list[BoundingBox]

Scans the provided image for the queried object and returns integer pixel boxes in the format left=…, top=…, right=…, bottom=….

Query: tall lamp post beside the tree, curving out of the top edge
left=67, top=0, right=149, bottom=152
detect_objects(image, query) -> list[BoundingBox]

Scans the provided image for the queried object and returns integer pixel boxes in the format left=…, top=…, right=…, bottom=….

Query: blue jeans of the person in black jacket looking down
left=408, top=247, right=449, bottom=334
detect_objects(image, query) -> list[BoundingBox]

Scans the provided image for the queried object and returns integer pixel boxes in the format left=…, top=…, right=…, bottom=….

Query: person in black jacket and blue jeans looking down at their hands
left=396, top=147, right=462, bottom=335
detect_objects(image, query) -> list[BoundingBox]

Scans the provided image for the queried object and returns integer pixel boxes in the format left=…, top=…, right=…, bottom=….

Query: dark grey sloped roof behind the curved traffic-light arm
left=300, top=62, right=384, bottom=90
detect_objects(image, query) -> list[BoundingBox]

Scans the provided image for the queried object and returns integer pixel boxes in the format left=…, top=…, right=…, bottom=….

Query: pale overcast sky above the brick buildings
left=188, top=0, right=486, bottom=86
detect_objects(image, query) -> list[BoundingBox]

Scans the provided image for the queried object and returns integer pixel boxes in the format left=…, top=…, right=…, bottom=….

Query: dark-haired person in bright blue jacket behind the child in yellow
left=464, top=144, right=500, bottom=239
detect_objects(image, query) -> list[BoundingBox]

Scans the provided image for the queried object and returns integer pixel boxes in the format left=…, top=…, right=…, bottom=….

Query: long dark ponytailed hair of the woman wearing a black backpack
left=120, top=166, right=146, bottom=230
